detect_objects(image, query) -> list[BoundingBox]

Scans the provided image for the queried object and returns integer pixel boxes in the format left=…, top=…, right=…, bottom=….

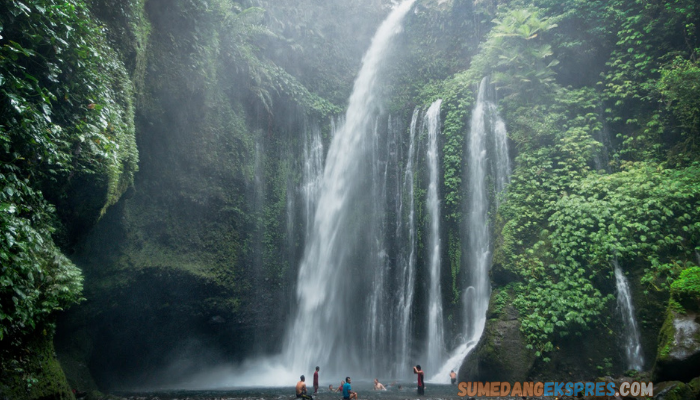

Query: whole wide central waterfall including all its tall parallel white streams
left=222, top=18, right=510, bottom=385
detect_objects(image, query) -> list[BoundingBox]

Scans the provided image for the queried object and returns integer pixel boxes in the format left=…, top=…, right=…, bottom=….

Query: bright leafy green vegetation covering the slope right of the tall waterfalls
left=469, top=1, right=700, bottom=361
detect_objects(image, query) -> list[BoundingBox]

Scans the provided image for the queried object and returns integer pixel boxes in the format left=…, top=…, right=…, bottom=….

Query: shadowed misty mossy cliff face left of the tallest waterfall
left=57, top=0, right=394, bottom=389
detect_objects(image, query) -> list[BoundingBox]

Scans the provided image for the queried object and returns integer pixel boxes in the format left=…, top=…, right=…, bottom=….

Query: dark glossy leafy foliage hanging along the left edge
left=0, top=0, right=137, bottom=340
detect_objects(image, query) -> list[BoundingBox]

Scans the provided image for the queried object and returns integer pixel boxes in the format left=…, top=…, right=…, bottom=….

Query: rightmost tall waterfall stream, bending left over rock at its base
left=431, top=77, right=511, bottom=383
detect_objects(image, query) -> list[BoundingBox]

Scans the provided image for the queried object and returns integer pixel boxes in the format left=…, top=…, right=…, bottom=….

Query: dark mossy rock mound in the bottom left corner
left=0, top=327, right=75, bottom=400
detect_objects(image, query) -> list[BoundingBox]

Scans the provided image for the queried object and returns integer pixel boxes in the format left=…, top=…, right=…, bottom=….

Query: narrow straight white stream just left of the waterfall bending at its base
left=423, top=100, right=445, bottom=370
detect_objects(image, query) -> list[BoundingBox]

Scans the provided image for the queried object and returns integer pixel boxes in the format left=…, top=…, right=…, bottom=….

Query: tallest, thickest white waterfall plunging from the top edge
left=282, top=0, right=415, bottom=374
